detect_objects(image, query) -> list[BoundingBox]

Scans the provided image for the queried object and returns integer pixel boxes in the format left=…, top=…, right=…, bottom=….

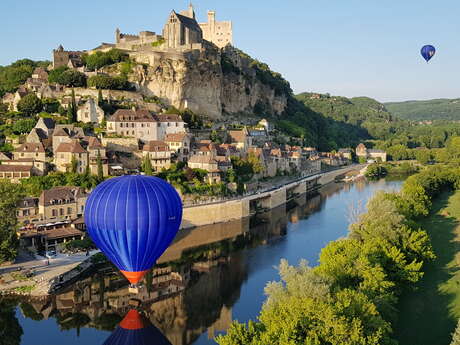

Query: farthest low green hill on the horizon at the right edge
left=385, top=98, right=460, bottom=121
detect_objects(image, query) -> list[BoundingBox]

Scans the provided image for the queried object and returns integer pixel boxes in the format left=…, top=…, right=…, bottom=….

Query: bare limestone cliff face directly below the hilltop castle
left=132, top=47, right=290, bottom=119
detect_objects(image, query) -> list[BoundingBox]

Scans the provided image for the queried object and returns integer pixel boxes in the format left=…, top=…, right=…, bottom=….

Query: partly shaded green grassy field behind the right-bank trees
left=395, top=191, right=460, bottom=345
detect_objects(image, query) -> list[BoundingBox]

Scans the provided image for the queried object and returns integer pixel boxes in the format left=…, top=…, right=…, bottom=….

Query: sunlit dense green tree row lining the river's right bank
left=216, top=167, right=460, bottom=345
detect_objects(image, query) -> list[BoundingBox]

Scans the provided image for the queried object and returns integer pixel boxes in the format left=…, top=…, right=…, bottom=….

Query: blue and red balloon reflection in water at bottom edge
left=103, top=310, right=171, bottom=345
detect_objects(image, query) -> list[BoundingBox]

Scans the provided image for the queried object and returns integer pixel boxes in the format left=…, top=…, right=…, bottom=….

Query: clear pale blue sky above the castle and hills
left=0, top=0, right=460, bottom=101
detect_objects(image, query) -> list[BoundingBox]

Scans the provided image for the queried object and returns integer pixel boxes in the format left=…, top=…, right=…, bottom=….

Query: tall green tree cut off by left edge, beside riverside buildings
left=0, top=180, right=24, bottom=263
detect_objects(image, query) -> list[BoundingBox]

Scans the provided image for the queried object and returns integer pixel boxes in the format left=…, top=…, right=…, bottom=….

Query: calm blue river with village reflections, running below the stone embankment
left=0, top=180, right=402, bottom=345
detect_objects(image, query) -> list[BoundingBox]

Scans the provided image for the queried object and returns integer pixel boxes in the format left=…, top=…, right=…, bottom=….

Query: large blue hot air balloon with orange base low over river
left=85, top=175, right=182, bottom=284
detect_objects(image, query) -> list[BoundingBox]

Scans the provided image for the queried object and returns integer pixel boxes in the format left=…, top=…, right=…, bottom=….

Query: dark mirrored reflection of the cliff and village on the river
left=3, top=191, right=328, bottom=345
